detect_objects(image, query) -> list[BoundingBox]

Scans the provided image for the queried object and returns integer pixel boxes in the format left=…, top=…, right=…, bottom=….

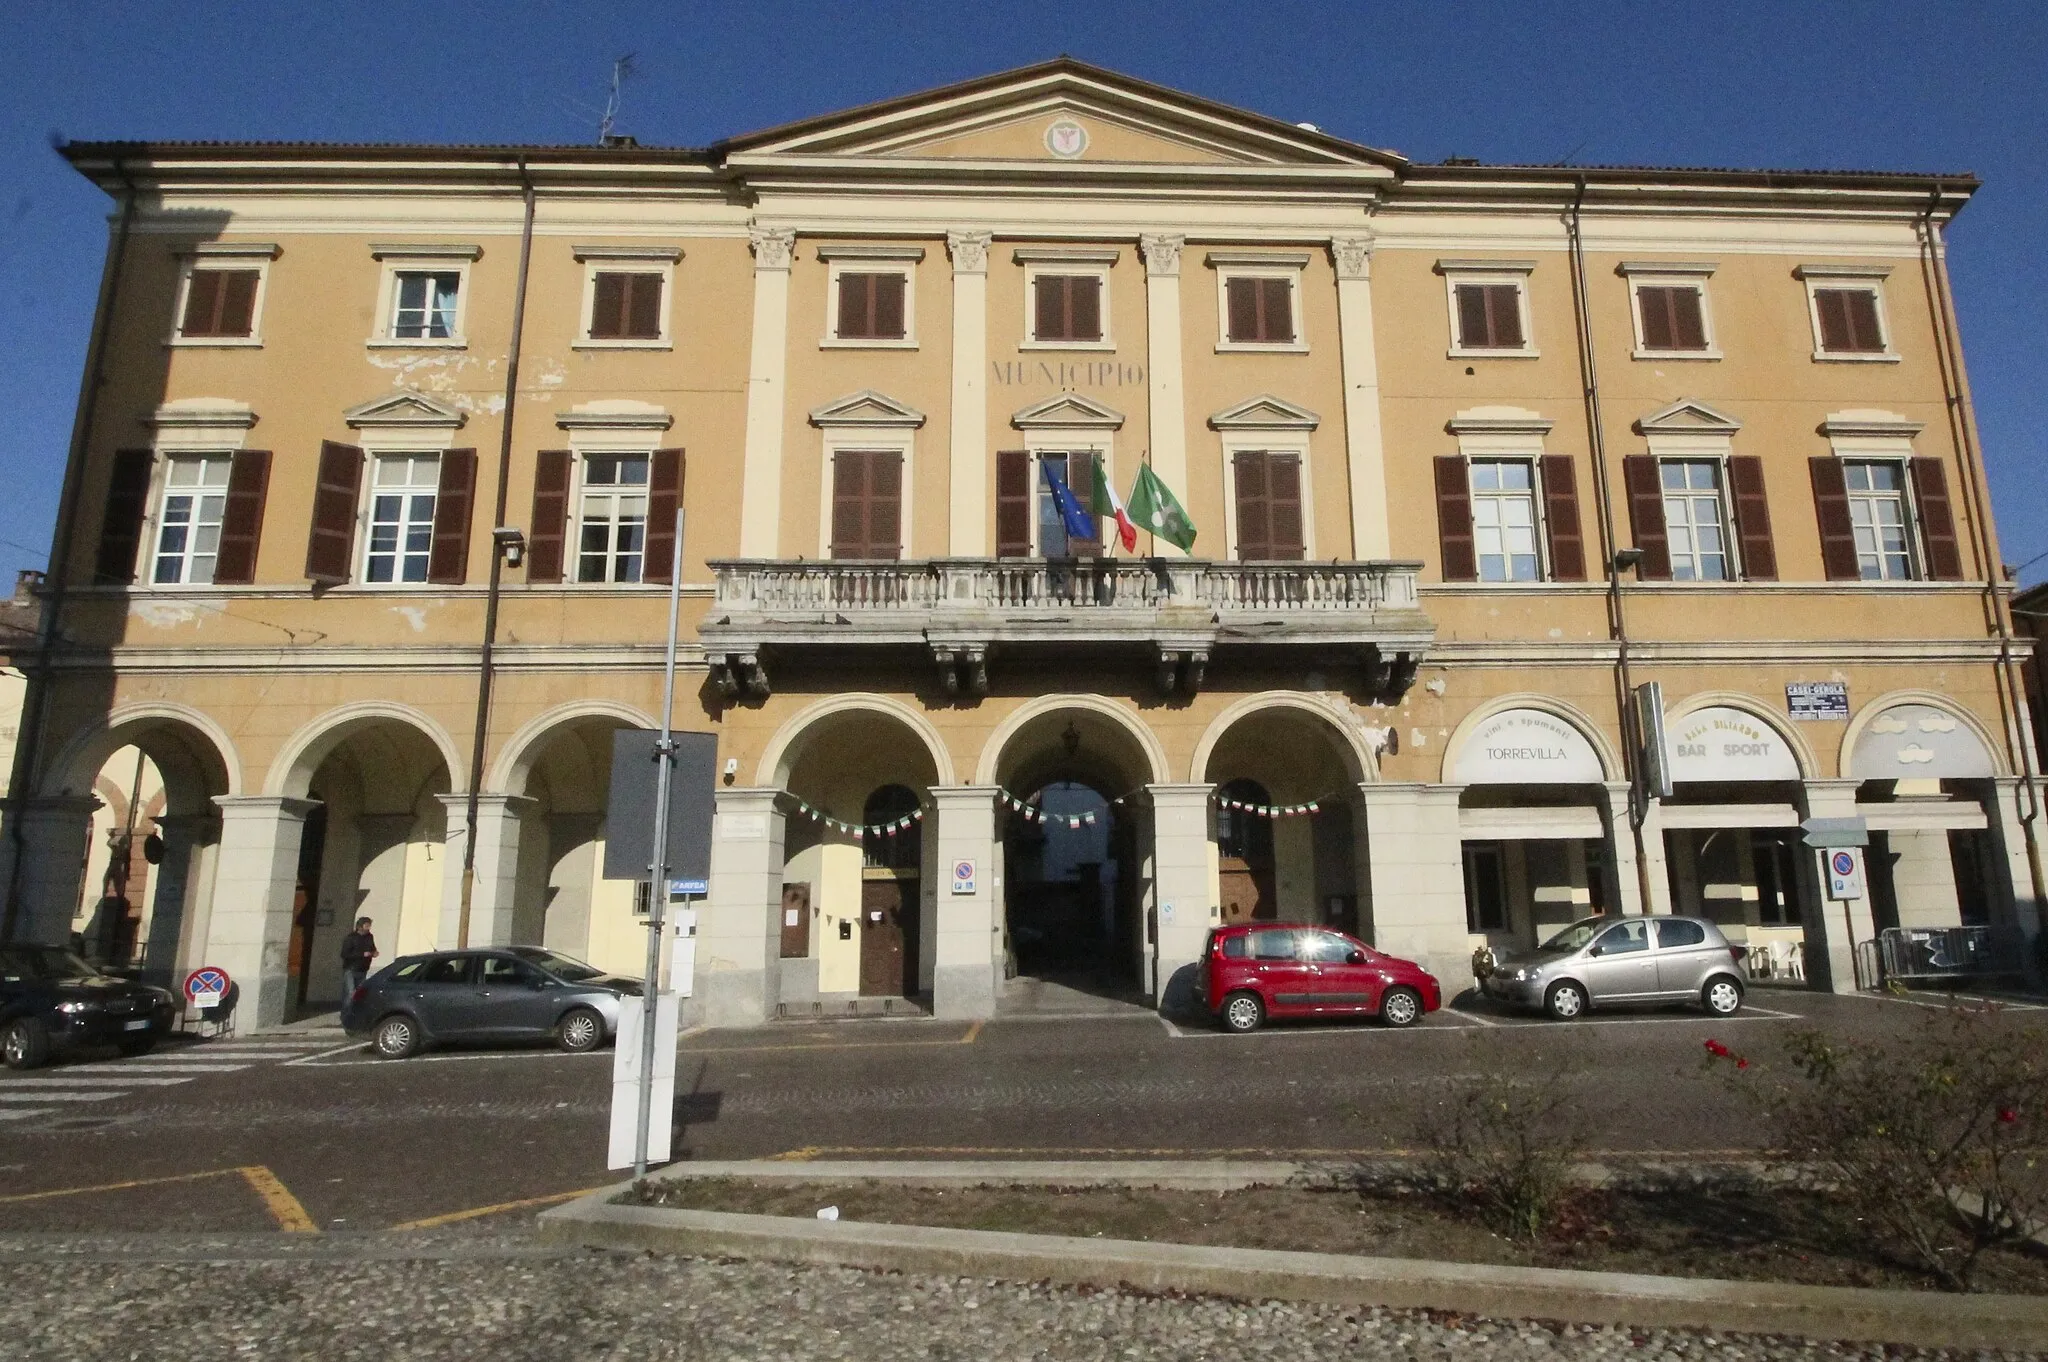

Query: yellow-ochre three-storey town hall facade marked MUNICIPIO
left=0, top=59, right=2042, bottom=1022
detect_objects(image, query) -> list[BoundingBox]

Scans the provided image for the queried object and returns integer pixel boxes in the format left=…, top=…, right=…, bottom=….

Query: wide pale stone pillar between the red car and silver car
left=1358, top=782, right=1473, bottom=999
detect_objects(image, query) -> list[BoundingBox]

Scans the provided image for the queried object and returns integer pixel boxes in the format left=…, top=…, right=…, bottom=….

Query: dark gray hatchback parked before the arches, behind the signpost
left=342, top=946, right=641, bottom=1059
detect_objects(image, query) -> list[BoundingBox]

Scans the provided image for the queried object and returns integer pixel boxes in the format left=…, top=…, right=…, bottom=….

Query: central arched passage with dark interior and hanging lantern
left=993, top=705, right=1157, bottom=1002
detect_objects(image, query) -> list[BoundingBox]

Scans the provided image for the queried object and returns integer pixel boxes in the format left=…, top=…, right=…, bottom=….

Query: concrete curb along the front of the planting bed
left=539, top=1163, right=2048, bottom=1350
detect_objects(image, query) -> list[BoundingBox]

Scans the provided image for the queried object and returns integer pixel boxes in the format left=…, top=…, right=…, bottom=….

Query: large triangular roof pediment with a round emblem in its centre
left=725, top=57, right=1403, bottom=170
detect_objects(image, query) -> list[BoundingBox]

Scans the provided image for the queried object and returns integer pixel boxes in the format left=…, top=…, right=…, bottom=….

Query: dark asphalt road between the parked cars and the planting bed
left=0, top=989, right=2015, bottom=1233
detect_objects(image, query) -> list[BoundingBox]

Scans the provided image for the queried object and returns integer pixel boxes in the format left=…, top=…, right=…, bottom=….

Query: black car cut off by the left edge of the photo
left=0, top=946, right=178, bottom=1069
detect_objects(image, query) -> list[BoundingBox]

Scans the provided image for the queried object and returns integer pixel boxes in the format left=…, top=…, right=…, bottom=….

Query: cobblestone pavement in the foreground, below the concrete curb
left=0, top=1233, right=2021, bottom=1362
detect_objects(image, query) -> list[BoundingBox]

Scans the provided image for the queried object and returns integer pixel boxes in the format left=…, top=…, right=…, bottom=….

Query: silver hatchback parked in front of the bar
left=1475, top=918, right=1743, bottom=1020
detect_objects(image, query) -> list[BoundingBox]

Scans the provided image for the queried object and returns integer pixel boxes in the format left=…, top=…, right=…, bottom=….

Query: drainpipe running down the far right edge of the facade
left=1921, top=180, right=2048, bottom=929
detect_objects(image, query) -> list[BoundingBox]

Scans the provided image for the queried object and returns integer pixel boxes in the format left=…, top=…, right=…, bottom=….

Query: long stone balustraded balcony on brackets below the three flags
left=698, top=557, right=1436, bottom=700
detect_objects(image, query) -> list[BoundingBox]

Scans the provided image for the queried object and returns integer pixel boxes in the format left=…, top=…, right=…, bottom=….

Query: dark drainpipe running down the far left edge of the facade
left=0, top=162, right=135, bottom=942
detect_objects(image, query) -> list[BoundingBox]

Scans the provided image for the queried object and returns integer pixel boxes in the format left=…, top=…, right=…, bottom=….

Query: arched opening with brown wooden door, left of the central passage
left=774, top=705, right=950, bottom=1014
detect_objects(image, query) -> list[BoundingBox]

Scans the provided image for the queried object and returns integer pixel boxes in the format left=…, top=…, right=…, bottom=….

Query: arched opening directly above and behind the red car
left=1196, top=698, right=1370, bottom=938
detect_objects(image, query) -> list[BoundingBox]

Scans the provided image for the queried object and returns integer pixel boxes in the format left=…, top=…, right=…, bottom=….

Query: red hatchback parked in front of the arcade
left=1196, top=922, right=1444, bottom=1032
